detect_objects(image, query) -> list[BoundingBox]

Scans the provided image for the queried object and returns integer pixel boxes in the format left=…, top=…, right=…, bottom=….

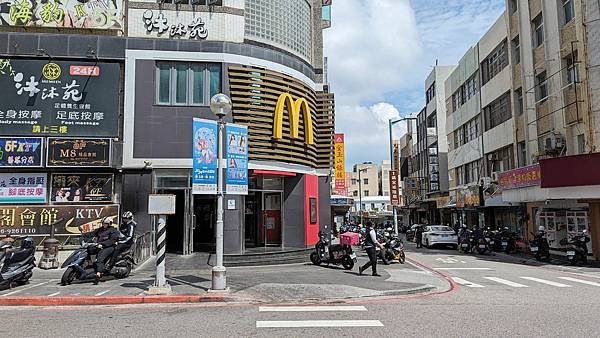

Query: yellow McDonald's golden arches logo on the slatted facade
left=273, top=93, right=314, bottom=144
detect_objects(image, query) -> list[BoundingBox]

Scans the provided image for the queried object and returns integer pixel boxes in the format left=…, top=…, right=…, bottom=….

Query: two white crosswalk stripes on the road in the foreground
left=256, top=305, right=384, bottom=329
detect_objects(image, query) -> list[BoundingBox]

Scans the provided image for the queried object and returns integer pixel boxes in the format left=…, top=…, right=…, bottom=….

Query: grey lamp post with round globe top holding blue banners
left=210, top=94, right=232, bottom=291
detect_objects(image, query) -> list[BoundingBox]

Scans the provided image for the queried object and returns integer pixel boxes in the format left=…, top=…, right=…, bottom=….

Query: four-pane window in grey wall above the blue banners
left=156, top=62, right=221, bottom=106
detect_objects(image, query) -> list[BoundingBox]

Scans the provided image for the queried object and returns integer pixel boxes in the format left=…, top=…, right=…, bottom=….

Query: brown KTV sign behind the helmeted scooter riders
left=0, top=204, right=119, bottom=236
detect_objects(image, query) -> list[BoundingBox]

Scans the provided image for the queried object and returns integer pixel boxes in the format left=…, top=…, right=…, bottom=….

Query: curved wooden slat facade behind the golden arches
left=228, top=65, right=334, bottom=169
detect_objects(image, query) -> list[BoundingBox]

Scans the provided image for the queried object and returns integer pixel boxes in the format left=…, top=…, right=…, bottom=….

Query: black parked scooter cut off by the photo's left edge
left=0, top=237, right=35, bottom=289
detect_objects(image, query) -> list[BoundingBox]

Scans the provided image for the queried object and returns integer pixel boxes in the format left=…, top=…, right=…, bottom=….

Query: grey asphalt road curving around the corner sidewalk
left=0, top=244, right=600, bottom=337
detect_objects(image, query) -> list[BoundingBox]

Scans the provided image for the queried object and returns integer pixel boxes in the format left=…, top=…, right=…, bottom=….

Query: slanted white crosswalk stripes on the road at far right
left=451, top=276, right=600, bottom=288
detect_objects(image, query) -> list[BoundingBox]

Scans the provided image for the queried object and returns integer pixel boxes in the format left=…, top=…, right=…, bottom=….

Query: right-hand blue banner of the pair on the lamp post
left=225, top=124, right=248, bottom=195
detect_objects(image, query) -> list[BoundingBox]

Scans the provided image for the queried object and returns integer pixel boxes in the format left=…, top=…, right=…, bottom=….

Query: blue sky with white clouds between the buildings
left=323, top=0, right=505, bottom=171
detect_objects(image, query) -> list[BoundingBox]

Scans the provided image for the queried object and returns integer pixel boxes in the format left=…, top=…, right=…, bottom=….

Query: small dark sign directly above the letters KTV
left=50, top=174, right=114, bottom=203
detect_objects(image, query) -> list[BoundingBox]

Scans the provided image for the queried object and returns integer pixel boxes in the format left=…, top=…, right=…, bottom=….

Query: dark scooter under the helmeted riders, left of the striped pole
left=60, top=237, right=134, bottom=286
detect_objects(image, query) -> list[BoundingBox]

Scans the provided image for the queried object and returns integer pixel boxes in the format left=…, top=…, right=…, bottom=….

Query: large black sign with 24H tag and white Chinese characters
left=0, top=58, right=119, bottom=137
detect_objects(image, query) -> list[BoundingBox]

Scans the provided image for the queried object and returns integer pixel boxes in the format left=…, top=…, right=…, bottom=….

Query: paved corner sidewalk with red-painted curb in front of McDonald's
left=0, top=256, right=443, bottom=306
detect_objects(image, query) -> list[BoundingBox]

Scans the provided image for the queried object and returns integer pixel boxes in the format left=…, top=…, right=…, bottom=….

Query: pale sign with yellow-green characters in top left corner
left=0, top=0, right=124, bottom=29
